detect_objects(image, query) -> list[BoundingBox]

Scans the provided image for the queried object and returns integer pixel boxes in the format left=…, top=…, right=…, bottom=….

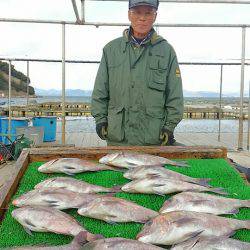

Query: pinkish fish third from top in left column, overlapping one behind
left=12, top=188, right=104, bottom=210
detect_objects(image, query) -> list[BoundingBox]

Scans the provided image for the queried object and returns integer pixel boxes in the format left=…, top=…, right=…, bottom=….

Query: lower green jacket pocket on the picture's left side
left=108, top=107, right=124, bottom=142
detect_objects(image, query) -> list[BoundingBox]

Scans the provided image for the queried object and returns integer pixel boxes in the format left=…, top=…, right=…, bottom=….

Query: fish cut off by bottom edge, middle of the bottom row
left=81, top=237, right=164, bottom=250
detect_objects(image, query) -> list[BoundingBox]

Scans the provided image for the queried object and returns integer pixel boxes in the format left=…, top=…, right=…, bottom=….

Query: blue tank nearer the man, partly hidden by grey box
left=32, top=116, right=56, bottom=142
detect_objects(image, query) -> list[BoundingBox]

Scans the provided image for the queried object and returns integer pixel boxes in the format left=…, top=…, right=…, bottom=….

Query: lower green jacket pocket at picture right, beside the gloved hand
left=145, top=107, right=165, bottom=145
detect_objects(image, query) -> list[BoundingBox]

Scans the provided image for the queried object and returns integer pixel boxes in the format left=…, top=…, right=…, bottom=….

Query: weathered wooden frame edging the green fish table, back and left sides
left=0, top=146, right=227, bottom=222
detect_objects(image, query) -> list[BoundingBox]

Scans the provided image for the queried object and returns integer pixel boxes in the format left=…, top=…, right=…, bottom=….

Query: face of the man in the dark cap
left=128, top=5, right=157, bottom=35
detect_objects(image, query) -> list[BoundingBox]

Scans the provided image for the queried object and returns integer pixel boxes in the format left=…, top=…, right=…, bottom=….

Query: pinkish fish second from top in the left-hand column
left=35, top=177, right=121, bottom=193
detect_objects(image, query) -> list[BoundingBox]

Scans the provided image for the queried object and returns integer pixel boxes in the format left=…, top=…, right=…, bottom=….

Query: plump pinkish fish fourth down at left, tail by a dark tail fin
left=11, top=206, right=101, bottom=241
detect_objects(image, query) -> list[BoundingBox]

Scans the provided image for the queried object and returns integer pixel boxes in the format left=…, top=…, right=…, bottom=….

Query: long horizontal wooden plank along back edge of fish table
left=29, top=146, right=227, bottom=162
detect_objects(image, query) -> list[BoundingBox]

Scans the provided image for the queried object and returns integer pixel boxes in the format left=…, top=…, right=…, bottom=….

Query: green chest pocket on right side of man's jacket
left=148, top=58, right=167, bottom=91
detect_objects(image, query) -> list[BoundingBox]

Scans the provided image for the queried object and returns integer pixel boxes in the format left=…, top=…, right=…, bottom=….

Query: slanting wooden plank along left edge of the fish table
left=0, top=149, right=29, bottom=221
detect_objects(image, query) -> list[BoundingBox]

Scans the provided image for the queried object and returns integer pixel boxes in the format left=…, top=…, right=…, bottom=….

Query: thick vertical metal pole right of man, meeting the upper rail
left=238, top=27, right=246, bottom=150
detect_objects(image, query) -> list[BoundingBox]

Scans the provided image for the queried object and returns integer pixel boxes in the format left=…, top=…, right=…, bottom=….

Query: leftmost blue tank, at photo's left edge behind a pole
left=1, top=117, right=28, bottom=144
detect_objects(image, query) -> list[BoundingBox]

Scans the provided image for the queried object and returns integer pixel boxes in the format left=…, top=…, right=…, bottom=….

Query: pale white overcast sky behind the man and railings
left=0, top=0, right=250, bottom=93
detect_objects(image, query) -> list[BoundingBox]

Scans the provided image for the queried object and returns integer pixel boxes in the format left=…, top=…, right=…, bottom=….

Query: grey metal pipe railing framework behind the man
left=0, top=0, right=250, bottom=150
